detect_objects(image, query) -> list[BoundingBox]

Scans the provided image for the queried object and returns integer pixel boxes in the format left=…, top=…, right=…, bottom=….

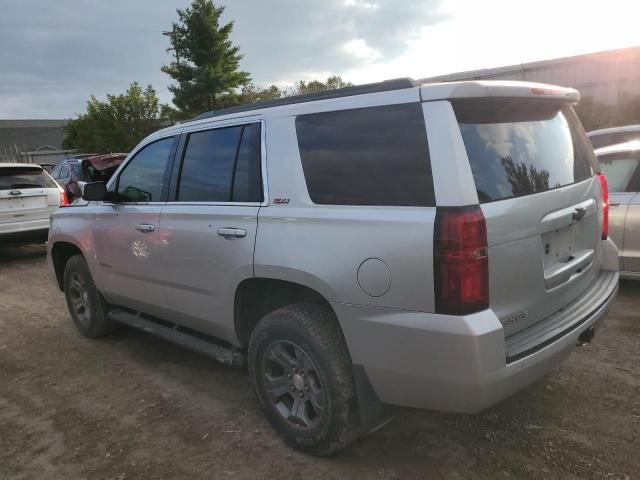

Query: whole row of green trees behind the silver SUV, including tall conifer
left=63, top=0, right=352, bottom=152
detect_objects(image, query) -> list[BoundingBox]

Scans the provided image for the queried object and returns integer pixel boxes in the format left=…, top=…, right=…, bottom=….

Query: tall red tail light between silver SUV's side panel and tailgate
left=433, top=205, right=489, bottom=315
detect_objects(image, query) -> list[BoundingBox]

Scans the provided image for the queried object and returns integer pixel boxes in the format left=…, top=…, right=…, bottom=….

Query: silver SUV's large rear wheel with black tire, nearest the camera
left=249, top=304, right=360, bottom=456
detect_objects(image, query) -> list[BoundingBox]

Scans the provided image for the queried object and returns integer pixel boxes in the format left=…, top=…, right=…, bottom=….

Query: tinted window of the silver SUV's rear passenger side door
left=178, top=123, right=262, bottom=202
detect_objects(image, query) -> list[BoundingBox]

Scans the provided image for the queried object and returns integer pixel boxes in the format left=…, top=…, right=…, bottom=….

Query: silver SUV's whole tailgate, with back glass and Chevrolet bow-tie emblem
left=452, top=99, right=602, bottom=336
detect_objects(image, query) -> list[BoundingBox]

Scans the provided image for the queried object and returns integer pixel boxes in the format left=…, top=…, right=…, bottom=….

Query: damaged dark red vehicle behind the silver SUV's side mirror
left=51, top=153, right=127, bottom=201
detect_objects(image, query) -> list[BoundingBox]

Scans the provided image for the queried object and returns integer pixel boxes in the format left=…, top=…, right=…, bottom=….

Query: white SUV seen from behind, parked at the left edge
left=0, top=163, right=69, bottom=243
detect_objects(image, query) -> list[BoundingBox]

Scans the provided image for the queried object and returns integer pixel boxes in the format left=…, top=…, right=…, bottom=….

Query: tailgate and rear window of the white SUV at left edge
left=0, top=165, right=60, bottom=229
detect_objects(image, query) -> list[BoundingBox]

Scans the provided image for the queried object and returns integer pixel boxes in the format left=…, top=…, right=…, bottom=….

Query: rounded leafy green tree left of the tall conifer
left=63, top=82, right=171, bottom=153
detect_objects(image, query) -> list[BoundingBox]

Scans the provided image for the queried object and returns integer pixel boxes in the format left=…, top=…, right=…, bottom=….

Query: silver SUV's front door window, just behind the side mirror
left=117, top=137, right=174, bottom=202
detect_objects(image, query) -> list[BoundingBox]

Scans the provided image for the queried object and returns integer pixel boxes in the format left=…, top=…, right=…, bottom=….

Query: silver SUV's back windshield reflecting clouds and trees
left=452, top=99, right=597, bottom=203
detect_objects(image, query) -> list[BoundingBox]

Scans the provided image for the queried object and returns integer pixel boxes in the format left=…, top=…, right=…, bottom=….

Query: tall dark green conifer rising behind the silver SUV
left=162, top=0, right=251, bottom=117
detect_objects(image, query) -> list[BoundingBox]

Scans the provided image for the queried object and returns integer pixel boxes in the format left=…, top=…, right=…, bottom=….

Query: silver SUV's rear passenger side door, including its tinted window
left=160, top=122, right=263, bottom=341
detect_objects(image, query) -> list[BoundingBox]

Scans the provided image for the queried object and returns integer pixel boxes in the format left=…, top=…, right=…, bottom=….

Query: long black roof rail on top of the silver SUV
left=190, top=77, right=422, bottom=121
